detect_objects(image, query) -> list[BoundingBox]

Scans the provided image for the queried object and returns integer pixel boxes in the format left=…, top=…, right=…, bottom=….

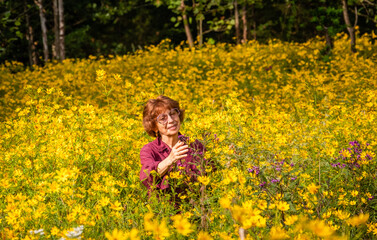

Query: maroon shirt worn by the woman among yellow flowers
left=140, top=137, right=204, bottom=190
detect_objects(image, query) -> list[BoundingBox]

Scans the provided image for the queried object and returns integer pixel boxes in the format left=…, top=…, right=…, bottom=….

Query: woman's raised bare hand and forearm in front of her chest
left=157, top=141, right=189, bottom=176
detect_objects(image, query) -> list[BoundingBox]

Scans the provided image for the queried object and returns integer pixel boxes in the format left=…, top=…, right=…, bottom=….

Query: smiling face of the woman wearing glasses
left=157, top=108, right=181, bottom=136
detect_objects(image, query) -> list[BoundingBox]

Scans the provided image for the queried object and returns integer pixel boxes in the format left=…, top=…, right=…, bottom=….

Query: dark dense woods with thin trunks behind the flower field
left=0, top=0, right=377, bottom=65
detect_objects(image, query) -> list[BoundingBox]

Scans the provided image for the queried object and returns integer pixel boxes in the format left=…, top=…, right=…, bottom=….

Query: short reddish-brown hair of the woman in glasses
left=143, top=95, right=185, bottom=137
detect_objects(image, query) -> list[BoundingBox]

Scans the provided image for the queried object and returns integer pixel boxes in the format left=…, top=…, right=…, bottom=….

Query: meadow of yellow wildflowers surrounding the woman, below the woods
left=0, top=34, right=377, bottom=240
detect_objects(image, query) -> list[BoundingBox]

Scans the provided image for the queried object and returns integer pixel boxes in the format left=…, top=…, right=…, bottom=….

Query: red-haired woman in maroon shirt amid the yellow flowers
left=140, top=96, right=204, bottom=193
